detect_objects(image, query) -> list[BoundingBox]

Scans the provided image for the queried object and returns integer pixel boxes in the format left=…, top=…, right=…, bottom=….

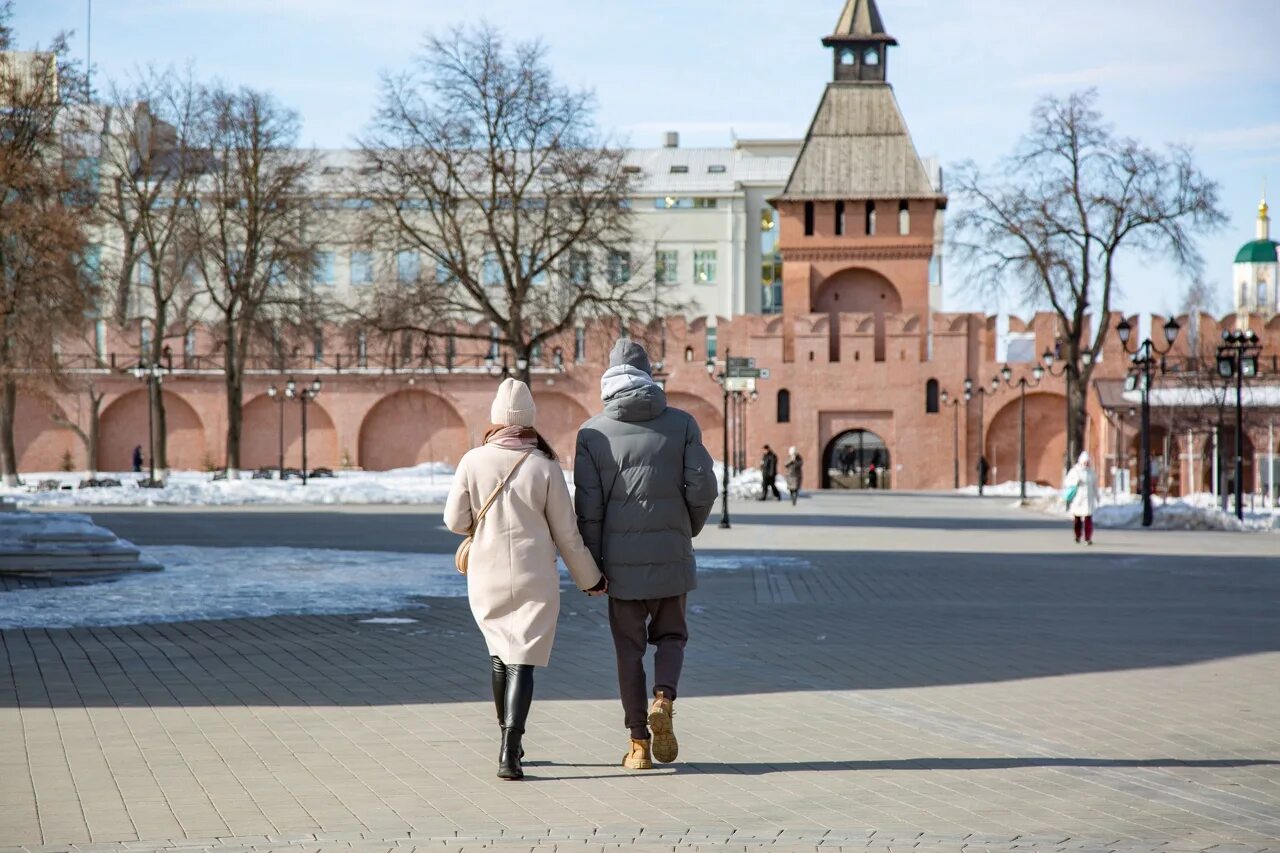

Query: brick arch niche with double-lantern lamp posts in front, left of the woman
left=241, top=394, right=340, bottom=470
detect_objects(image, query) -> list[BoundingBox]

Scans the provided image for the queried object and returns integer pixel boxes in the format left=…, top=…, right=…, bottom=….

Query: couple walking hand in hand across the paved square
left=444, top=338, right=718, bottom=779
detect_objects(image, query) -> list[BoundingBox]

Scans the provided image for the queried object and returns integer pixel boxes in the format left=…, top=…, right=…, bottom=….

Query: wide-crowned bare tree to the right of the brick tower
left=952, top=90, right=1225, bottom=459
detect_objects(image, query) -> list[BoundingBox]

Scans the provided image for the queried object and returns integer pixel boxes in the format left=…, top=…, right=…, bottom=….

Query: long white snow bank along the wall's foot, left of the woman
left=0, top=462, right=453, bottom=506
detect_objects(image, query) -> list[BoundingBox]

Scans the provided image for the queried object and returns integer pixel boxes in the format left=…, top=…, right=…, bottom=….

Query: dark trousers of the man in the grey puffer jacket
left=609, top=596, right=689, bottom=739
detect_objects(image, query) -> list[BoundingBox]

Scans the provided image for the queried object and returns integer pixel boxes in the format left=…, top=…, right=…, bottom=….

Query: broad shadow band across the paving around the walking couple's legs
left=0, top=549, right=1280, bottom=712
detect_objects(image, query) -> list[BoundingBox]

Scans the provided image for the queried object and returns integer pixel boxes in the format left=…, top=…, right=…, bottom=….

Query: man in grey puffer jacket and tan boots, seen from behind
left=573, top=338, right=717, bottom=770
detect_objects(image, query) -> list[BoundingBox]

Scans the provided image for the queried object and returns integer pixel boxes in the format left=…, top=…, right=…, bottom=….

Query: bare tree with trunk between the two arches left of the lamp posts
left=193, top=87, right=320, bottom=476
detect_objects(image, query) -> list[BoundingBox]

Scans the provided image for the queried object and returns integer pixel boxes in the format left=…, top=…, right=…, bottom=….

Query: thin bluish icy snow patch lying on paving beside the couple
left=0, top=546, right=809, bottom=629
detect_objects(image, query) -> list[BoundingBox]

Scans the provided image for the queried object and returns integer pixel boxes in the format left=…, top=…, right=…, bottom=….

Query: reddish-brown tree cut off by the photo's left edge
left=0, top=1, right=95, bottom=485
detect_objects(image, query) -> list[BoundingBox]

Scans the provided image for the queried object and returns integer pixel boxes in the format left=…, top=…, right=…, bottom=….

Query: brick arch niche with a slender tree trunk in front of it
left=97, top=388, right=209, bottom=471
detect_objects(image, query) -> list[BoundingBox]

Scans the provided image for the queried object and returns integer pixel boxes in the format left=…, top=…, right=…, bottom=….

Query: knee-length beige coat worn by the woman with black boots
left=444, top=444, right=602, bottom=666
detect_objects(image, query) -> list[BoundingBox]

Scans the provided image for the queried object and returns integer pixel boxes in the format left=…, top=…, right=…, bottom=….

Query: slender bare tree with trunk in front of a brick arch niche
left=100, top=69, right=206, bottom=470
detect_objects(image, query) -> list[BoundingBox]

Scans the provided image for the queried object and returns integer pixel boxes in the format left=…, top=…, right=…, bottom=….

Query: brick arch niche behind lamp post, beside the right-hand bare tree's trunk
left=983, top=392, right=1066, bottom=485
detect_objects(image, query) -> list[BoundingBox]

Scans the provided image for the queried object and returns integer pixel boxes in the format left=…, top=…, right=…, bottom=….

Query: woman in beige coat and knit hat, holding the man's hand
left=444, top=379, right=607, bottom=779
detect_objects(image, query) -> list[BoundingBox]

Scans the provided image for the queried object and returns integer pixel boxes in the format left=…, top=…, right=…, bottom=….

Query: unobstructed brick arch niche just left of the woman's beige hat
left=360, top=391, right=470, bottom=471
